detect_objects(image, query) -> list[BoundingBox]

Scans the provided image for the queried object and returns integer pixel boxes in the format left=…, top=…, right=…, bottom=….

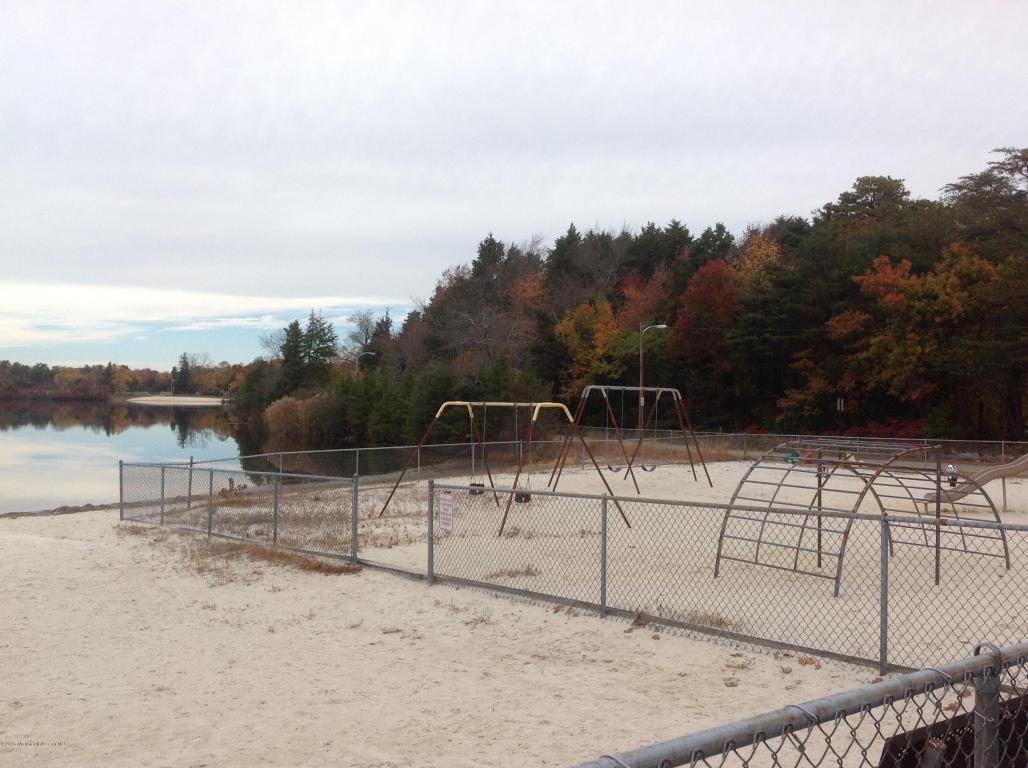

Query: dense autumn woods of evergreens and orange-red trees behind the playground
left=237, top=148, right=1028, bottom=446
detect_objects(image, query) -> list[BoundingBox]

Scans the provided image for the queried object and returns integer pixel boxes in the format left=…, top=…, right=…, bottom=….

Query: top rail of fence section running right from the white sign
left=430, top=480, right=1028, bottom=533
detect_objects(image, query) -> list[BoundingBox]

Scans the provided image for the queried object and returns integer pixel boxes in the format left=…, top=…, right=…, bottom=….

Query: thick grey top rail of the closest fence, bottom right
left=577, top=643, right=1028, bottom=768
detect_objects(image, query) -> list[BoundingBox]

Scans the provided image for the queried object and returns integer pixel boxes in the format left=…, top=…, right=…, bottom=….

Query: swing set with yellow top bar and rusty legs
left=378, top=400, right=631, bottom=536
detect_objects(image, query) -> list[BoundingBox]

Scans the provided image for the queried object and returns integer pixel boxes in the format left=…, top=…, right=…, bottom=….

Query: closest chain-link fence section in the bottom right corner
left=579, top=644, right=1028, bottom=768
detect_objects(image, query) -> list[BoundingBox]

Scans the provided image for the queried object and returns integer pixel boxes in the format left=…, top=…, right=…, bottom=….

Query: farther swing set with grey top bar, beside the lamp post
left=547, top=385, right=713, bottom=493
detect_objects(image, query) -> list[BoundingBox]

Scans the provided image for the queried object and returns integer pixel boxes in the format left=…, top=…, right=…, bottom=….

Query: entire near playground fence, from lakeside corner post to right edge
left=120, top=464, right=1028, bottom=671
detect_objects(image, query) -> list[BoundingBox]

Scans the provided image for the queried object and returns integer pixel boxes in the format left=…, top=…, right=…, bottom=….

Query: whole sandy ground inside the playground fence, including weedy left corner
left=142, top=462, right=1028, bottom=667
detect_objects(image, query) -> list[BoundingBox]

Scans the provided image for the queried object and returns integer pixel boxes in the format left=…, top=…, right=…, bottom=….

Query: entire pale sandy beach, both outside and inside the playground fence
left=8, top=462, right=1028, bottom=767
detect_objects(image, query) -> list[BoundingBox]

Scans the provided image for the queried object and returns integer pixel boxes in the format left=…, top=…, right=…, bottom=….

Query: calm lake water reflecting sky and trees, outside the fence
left=0, top=401, right=248, bottom=512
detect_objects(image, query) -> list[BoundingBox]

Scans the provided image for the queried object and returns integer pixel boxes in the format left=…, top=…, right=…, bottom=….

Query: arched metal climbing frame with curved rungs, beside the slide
left=714, top=438, right=1011, bottom=597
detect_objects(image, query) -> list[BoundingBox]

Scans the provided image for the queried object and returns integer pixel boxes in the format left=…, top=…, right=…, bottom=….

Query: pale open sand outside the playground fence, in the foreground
left=0, top=511, right=873, bottom=768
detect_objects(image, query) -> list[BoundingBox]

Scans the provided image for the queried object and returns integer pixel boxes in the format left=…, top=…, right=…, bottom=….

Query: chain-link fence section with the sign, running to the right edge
left=429, top=483, right=1028, bottom=672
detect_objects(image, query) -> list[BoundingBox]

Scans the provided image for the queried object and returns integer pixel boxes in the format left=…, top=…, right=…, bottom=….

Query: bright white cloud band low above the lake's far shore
left=0, top=282, right=404, bottom=348
